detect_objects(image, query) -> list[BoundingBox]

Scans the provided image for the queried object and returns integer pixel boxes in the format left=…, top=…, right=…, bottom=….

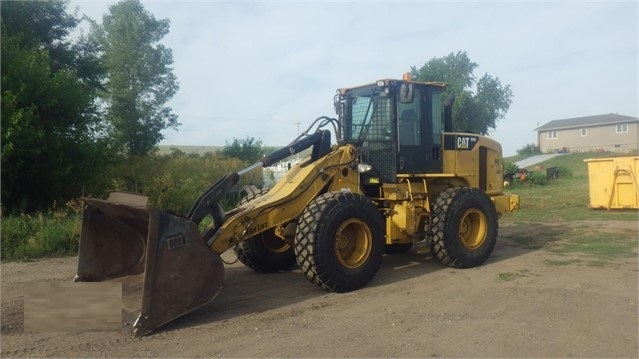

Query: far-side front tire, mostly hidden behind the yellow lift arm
left=234, top=189, right=295, bottom=273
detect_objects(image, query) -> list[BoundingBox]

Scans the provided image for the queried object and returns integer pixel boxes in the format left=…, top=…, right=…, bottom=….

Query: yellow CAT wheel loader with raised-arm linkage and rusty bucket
left=75, top=76, right=519, bottom=336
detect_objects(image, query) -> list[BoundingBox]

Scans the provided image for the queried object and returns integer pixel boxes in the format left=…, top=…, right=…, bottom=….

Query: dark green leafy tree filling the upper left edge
left=0, top=1, right=108, bottom=212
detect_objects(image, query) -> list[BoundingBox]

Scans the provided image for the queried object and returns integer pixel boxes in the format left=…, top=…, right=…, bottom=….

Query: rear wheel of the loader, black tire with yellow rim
left=431, top=187, right=498, bottom=268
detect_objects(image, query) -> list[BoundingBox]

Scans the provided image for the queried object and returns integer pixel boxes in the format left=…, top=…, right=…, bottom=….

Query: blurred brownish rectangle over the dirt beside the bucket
left=24, top=282, right=122, bottom=332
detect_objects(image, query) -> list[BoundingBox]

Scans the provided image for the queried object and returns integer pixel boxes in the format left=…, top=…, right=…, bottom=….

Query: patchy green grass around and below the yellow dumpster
left=500, top=153, right=639, bottom=266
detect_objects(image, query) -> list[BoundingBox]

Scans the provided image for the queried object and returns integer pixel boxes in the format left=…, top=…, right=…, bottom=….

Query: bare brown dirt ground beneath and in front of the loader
left=0, top=221, right=639, bottom=358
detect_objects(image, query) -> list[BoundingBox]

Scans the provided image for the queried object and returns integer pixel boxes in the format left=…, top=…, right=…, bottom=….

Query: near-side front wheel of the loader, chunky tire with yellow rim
left=295, top=192, right=384, bottom=292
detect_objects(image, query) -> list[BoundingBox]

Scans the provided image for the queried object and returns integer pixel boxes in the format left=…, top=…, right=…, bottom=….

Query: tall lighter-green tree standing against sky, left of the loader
left=92, top=0, right=179, bottom=155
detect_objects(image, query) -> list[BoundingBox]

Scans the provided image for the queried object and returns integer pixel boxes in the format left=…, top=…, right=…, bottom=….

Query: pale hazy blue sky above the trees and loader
left=69, top=0, right=639, bottom=156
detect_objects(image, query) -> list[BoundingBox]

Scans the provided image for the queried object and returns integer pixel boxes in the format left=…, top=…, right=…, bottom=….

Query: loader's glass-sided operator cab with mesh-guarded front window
left=335, top=74, right=446, bottom=185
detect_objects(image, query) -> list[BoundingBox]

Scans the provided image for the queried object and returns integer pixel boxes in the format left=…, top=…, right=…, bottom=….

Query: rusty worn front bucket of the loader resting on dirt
left=75, top=193, right=224, bottom=336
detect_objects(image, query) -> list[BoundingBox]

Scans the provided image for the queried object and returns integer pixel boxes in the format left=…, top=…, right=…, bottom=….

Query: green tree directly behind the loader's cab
left=411, top=52, right=513, bottom=135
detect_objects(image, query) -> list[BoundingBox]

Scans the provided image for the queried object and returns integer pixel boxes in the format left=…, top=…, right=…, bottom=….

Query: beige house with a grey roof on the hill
left=535, top=113, right=639, bottom=153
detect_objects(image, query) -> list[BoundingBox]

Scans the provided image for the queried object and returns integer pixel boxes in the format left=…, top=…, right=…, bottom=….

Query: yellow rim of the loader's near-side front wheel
left=335, top=218, right=373, bottom=268
